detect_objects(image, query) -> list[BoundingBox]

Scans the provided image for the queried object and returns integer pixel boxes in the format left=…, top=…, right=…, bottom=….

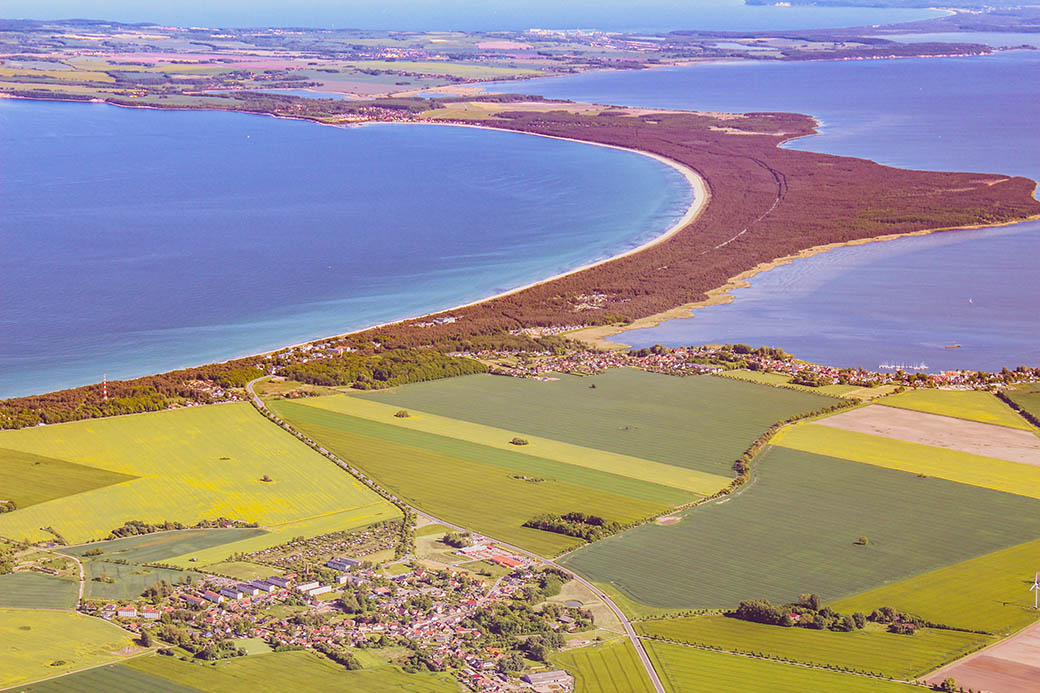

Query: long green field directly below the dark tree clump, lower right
left=635, top=611, right=994, bottom=679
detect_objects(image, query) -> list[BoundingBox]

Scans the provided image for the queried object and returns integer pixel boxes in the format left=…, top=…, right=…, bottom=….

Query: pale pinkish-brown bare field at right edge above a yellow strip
left=816, top=405, right=1040, bottom=466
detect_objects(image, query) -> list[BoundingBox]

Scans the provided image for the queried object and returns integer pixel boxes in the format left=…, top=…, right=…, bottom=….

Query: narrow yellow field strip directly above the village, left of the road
left=162, top=505, right=400, bottom=569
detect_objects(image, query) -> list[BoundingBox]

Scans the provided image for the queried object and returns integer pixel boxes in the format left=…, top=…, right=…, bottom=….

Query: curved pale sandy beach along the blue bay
left=252, top=121, right=711, bottom=355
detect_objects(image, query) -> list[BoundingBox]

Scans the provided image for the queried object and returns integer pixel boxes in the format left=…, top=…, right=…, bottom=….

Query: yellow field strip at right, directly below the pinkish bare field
left=773, top=424, right=1040, bottom=499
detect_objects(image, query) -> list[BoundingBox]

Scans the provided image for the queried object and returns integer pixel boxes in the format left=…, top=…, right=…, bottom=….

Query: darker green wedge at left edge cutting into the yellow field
left=0, top=448, right=136, bottom=508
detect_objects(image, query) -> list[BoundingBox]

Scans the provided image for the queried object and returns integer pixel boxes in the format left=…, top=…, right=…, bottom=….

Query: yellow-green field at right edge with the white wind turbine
left=831, top=540, right=1040, bottom=635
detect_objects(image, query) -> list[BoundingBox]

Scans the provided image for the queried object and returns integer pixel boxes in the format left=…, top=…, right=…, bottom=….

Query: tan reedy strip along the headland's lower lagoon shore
left=567, top=214, right=1040, bottom=351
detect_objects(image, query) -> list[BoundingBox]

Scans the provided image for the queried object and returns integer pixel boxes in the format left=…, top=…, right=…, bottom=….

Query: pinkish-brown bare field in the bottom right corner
left=928, top=623, right=1040, bottom=693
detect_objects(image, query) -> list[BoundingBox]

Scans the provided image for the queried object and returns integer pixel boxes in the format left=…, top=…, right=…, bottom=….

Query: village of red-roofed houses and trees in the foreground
left=80, top=522, right=594, bottom=692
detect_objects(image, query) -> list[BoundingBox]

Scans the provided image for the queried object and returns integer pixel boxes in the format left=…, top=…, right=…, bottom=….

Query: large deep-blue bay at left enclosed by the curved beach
left=0, top=100, right=693, bottom=396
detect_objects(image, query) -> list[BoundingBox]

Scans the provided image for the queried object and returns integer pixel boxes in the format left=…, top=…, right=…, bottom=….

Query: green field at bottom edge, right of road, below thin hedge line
left=645, top=642, right=922, bottom=693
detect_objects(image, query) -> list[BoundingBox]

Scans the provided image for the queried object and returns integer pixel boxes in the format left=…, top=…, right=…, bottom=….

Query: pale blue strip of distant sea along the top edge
left=0, top=0, right=935, bottom=31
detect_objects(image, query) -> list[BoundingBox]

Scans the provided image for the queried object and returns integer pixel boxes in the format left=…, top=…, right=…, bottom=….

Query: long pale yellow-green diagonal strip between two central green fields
left=287, top=394, right=731, bottom=495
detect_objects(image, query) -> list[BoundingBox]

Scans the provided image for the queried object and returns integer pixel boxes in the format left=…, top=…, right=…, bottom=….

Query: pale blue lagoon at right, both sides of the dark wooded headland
left=494, top=51, right=1040, bottom=371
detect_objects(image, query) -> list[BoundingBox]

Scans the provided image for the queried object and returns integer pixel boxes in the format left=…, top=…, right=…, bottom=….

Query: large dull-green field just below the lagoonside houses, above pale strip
left=364, top=368, right=838, bottom=477
